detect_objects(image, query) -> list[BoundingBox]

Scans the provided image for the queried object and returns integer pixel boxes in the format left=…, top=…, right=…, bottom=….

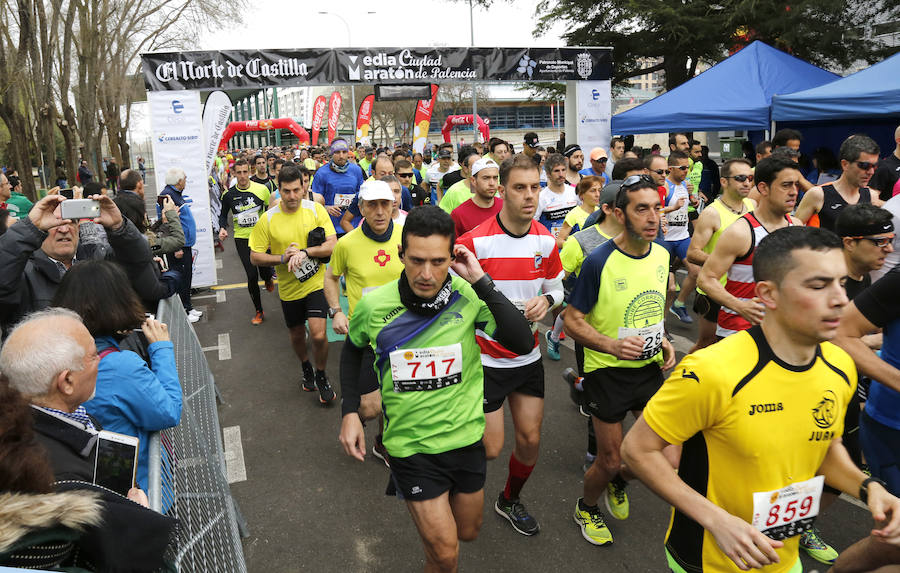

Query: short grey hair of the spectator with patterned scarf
left=0, top=307, right=85, bottom=398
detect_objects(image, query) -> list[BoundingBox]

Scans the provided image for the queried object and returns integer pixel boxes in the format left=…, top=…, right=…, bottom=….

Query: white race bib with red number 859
left=751, top=476, right=825, bottom=541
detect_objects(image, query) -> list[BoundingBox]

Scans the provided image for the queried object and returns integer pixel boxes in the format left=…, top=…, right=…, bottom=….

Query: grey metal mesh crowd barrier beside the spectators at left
left=147, top=296, right=247, bottom=573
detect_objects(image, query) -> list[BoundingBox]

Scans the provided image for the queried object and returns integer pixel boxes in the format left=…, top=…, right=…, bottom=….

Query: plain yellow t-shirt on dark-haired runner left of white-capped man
left=250, top=199, right=335, bottom=300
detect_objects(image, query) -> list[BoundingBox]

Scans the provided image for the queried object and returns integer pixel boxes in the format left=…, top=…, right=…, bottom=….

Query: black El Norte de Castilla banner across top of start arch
left=141, top=47, right=612, bottom=91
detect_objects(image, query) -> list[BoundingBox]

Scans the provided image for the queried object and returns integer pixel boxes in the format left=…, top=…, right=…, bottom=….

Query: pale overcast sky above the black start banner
left=194, top=0, right=563, bottom=50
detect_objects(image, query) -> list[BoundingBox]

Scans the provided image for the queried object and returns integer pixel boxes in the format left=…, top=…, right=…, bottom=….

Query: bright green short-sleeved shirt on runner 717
left=349, top=276, right=496, bottom=458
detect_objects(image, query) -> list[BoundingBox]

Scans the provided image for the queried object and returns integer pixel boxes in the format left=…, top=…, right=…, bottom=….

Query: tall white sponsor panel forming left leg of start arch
left=147, top=91, right=218, bottom=287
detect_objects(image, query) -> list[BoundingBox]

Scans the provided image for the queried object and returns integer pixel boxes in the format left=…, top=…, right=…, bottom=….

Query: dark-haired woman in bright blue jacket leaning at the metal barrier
left=53, top=261, right=181, bottom=490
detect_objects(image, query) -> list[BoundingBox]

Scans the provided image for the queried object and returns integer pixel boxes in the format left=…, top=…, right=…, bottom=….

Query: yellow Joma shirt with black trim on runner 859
left=644, top=326, right=856, bottom=573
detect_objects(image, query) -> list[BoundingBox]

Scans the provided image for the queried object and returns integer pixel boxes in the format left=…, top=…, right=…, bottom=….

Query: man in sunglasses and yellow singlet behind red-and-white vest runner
left=687, top=158, right=755, bottom=352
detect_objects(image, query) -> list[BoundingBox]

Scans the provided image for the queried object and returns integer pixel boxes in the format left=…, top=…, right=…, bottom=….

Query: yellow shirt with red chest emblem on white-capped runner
left=331, top=221, right=403, bottom=318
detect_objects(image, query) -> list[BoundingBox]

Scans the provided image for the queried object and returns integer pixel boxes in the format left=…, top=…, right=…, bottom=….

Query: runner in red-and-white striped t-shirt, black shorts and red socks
left=457, top=154, right=564, bottom=535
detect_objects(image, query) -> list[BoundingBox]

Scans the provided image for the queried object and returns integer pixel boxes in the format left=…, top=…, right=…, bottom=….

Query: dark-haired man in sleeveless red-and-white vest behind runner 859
left=697, top=157, right=803, bottom=339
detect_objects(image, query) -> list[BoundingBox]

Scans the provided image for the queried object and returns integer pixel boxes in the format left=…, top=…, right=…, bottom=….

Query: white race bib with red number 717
left=390, top=342, right=462, bottom=392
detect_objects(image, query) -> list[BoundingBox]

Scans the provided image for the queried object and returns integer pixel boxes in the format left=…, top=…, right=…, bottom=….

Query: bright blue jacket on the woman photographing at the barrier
left=84, top=336, right=181, bottom=491
